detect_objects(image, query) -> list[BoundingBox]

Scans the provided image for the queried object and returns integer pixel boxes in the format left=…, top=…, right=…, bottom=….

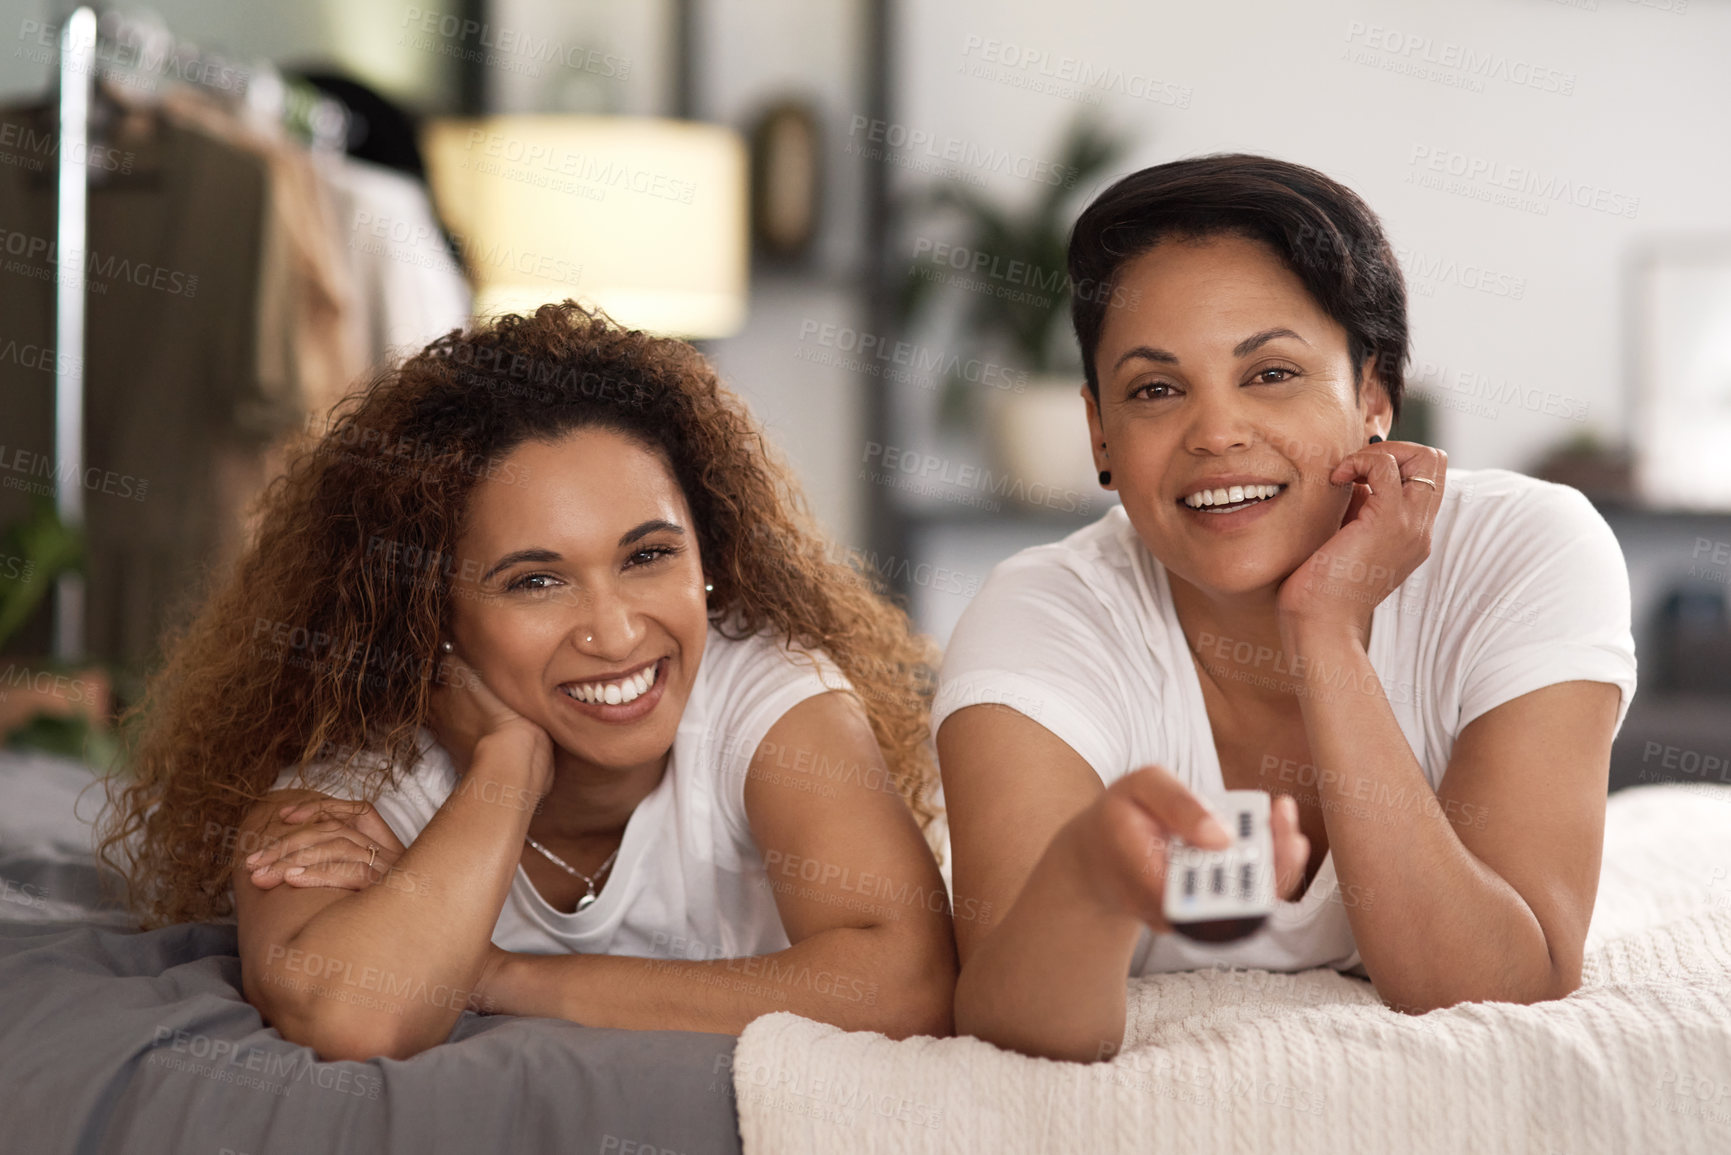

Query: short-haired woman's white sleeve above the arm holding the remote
left=931, top=551, right=1155, bottom=783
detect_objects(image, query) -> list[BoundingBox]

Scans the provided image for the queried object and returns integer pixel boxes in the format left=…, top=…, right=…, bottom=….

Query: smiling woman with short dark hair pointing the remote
left=933, top=156, right=1634, bottom=1060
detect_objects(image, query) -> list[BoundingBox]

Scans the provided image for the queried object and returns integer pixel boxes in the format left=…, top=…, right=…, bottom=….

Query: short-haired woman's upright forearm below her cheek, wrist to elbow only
left=1291, top=634, right=1567, bottom=1011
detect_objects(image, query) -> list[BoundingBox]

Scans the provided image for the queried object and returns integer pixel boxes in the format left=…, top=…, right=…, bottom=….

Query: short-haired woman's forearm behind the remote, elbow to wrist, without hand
left=956, top=826, right=1142, bottom=1061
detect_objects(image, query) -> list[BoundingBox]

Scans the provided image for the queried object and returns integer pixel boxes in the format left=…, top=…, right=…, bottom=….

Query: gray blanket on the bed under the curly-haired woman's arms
left=0, top=921, right=739, bottom=1155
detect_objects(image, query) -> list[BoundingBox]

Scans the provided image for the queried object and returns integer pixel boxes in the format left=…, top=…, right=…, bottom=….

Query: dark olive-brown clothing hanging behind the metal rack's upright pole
left=0, top=107, right=280, bottom=665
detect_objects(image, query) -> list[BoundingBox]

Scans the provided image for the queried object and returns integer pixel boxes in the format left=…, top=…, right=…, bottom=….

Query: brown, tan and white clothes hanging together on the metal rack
left=0, top=61, right=471, bottom=670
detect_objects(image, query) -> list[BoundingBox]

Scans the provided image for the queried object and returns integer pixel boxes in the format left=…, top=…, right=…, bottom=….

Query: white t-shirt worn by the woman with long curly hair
left=275, top=625, right=852, bottom=959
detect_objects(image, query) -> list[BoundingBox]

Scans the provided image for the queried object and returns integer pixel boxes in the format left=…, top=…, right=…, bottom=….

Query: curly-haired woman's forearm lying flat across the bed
left=488, top=923, right=954, bottom=1037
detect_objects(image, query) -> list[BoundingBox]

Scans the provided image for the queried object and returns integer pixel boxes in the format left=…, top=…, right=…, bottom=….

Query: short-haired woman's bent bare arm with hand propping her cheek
left=1279, top=442, right=1620, bottom=1013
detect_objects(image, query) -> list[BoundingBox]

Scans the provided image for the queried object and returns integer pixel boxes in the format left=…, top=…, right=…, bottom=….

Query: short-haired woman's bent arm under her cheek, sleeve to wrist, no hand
left=1298, top=641, right=1618, bottom=1013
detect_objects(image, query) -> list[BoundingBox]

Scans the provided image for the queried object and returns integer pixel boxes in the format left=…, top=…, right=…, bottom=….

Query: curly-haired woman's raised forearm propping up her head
left=265, top=745, right=533, bottom=1056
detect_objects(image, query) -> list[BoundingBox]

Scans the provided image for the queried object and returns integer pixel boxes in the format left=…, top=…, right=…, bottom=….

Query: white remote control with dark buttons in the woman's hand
left=1165, top=790, right=1274, bottom=942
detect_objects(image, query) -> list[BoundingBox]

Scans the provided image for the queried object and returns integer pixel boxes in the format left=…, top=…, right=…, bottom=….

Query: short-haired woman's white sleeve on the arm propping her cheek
left=1459, top=485, right=1636, bottom=729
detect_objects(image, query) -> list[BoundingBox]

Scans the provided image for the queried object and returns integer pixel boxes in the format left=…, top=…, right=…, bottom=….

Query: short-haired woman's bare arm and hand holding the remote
left=938, top=707, right=1309, bottom=1061
